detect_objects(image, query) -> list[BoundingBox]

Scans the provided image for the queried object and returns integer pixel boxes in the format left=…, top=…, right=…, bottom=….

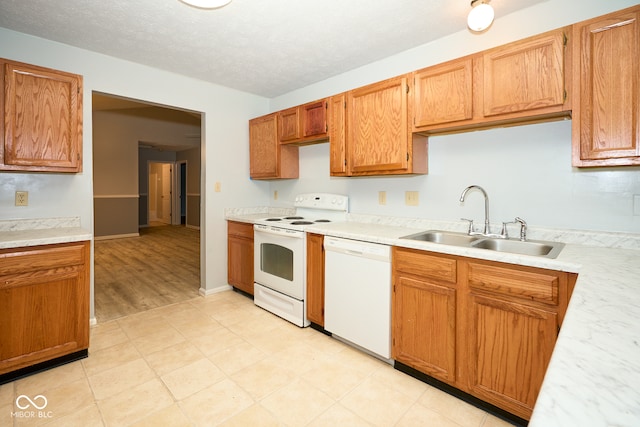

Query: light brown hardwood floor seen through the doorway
left=94, top=225, right=200, bottom=323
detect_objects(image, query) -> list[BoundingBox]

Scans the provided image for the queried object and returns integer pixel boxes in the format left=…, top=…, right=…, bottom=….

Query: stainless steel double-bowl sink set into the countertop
left=401, top=230, right=564, bottom=258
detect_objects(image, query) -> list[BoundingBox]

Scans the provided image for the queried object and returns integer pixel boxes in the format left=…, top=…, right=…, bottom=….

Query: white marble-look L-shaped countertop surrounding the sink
left=227, top=211, right=640, bottom=427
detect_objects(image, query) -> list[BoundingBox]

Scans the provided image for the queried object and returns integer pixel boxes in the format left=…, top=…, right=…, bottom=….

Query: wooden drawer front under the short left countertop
left=0, top=243, right=86, bottom=276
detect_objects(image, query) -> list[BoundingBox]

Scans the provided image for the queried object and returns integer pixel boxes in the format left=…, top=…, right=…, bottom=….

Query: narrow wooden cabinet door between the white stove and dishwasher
left=307, top=233, right=324, bottom=326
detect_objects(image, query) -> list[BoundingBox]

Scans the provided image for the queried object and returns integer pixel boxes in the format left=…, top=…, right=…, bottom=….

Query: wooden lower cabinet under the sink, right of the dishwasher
left=392, top=247, right=577, bottom=419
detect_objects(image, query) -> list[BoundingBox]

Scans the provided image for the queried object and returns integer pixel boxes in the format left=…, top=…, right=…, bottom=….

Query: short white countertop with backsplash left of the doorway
left=0, top=217, right=92, bottom=249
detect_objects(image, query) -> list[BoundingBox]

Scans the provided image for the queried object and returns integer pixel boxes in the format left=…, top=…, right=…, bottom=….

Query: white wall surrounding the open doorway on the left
left=0, top=28, right=269, bottom=306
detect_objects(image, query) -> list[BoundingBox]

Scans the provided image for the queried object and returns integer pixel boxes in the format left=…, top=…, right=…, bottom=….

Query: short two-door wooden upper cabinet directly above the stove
left=278, top=99, right=328, bottom=144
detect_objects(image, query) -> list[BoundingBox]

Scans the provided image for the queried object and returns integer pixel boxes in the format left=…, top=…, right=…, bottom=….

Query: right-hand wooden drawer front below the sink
left=468, top=262, right=560, bottom=305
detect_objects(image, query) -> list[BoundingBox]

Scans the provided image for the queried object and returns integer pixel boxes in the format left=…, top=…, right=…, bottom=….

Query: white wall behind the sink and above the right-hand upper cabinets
left=270, top=0, right=640, bottom=233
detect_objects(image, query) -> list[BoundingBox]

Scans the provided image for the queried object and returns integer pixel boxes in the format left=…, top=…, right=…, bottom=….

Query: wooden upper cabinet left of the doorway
left=0, top=59, right=82, bottom=172
